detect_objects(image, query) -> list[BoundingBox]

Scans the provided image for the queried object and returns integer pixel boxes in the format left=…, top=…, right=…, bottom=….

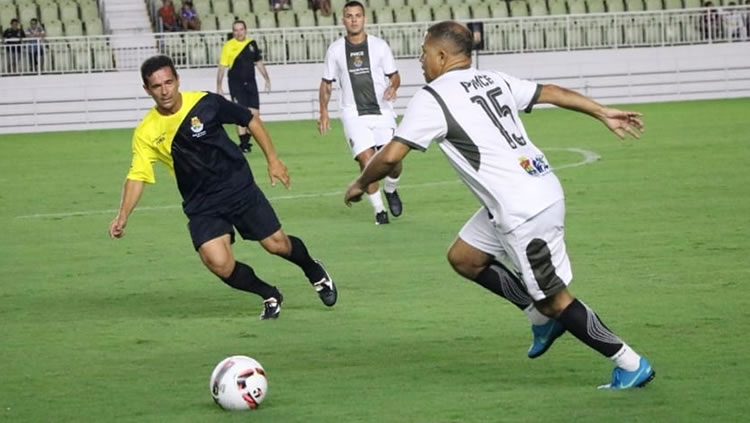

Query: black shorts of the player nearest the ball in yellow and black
left=188, top=185, right=281, bottom=251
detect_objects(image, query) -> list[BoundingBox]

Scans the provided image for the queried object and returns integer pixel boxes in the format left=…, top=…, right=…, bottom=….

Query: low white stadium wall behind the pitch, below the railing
left=0, top=42, right=750, bottom=133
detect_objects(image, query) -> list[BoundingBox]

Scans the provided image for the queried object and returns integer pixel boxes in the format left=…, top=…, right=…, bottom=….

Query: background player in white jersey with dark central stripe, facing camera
left=318, top=1, right=403, bottom=225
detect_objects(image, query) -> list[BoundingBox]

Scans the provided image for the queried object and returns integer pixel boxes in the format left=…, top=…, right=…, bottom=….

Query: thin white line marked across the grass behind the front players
left=15, top=148, right=601, bottom=219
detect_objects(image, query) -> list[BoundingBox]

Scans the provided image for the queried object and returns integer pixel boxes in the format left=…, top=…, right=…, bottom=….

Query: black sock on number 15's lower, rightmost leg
left=557, top=299, right=623, bottom=357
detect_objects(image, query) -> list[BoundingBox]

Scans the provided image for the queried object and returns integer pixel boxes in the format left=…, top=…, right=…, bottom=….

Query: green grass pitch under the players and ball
left=0, top=99, right=750, bottom=423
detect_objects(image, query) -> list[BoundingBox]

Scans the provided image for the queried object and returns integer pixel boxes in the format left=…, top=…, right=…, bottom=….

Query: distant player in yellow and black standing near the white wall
left=216, top=20, right=271, bottom=153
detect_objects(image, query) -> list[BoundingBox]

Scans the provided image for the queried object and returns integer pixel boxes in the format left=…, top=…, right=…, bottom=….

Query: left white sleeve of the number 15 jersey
left=393, top=89, right=448, bottom=151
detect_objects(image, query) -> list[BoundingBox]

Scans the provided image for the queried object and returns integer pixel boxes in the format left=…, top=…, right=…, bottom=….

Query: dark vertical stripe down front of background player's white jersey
left=344, top=39, right=380, bottom=116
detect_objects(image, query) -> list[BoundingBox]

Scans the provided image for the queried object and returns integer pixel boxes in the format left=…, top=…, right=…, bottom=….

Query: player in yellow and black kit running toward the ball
left=109, top=56, right=337, bottom=319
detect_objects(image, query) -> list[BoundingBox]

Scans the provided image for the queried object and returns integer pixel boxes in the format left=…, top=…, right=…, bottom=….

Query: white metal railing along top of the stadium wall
left=0, top=6, right=750, bottom=76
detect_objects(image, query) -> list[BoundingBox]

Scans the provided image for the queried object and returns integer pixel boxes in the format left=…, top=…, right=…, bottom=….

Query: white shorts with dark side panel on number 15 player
left=458, top=201, right=573, bottom=301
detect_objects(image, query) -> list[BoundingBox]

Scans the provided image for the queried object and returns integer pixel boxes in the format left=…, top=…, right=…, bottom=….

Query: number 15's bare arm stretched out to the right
left=537, top=85, right=644, bottom=139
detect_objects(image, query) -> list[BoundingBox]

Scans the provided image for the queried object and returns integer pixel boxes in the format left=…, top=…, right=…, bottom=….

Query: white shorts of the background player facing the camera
left=341, top=112, right=396, bottom=158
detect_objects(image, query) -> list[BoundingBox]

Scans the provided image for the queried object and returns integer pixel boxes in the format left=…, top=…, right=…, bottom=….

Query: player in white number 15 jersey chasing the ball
left=345, top=21, right=654, bottom=389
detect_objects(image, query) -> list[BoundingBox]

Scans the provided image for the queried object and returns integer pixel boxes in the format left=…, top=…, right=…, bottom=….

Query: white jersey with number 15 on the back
left=394, top=68, right=563, bottom=231
